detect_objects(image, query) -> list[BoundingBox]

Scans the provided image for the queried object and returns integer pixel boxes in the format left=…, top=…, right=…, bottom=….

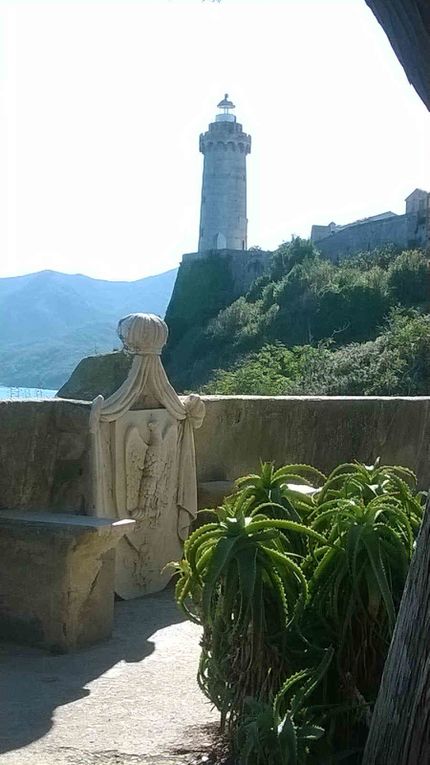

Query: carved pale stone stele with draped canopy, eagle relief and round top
left=90, top=313, right=205, bottom=599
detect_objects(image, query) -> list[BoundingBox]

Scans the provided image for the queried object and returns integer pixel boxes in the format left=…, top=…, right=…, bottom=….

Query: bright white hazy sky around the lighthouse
left=0, top=0, right=430, bottom=279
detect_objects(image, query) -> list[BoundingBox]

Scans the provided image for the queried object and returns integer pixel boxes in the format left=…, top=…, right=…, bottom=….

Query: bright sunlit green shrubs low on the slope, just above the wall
left=204, top=311, right=430, bottom=396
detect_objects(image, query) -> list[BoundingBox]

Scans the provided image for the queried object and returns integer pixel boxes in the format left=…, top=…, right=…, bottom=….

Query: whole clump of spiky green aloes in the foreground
left=176, top=462, right=423, bottom=765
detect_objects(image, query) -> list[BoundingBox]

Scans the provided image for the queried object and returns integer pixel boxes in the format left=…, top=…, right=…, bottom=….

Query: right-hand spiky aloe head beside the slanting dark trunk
left=304, top=463, right=422, bottom=694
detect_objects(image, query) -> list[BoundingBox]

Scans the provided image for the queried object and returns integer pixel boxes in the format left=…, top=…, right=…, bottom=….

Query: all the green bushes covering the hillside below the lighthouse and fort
left=165, top=238, right=430, bottom=395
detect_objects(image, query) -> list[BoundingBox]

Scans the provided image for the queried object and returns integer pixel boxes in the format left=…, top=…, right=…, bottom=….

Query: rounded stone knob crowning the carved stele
left=118, top=313, right=169, bottom=356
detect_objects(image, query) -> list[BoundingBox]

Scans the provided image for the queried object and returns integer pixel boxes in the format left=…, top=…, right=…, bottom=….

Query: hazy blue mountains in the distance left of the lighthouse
left=0, top=269, right=177, bottom=388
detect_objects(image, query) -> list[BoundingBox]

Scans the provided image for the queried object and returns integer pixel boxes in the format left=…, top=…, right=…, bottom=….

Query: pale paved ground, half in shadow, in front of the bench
left=0, top=590, right=218, bottom=765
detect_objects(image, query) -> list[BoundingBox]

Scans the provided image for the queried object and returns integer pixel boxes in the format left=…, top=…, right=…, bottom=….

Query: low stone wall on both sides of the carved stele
left=0, top=396, right=430, bottom=513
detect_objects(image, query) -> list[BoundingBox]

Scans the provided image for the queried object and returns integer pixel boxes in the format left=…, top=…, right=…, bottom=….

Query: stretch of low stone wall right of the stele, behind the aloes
left=196, top=396, right=430, bottom=488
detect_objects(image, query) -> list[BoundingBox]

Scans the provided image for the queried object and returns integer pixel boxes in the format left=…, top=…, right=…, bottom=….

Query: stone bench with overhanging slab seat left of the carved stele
left=0, top=510, right=134, bottom=652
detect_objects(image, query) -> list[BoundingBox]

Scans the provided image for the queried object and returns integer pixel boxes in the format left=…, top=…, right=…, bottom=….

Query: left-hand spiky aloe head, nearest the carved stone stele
left=176, top=493, right=325, bottom=724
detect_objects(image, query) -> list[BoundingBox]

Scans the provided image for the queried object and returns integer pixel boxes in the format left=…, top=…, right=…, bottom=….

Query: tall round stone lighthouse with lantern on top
left=199, top=93, right=251, bottom=253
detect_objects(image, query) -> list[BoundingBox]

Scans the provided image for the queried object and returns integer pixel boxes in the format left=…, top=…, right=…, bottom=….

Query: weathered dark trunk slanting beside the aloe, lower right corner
left=363, top=492, right=430, bottom=765
